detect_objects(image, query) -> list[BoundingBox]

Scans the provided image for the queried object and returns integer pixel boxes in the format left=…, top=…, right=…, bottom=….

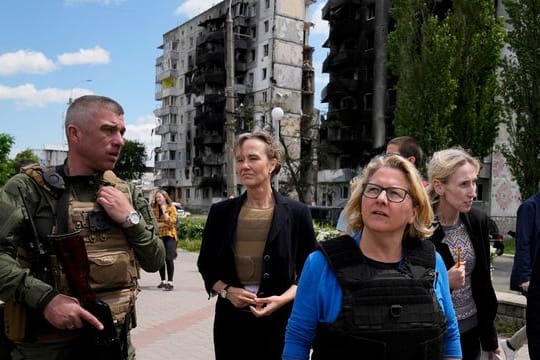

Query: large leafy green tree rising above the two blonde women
left=388, top=0, right=505, bottom=157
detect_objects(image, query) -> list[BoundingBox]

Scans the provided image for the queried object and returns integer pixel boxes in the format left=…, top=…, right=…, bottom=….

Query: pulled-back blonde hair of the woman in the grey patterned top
left=427, top=147, right=480, bottom=205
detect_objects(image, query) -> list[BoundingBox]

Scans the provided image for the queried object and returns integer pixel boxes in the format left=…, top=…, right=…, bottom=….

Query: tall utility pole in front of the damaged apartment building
left=225, top=0, right=236, bottom=197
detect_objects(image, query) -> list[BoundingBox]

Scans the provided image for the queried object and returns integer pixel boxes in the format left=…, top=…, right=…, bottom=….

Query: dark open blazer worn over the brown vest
left=197, top=191, right=317, bottom=302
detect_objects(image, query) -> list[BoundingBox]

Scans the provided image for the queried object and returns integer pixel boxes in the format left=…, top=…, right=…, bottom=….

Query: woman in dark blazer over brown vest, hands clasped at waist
left=197, top=131, right=317, bottom=360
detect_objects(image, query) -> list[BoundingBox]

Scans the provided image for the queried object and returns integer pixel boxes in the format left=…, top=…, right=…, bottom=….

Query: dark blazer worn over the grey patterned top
left=430, top=209, right=499, bottom=351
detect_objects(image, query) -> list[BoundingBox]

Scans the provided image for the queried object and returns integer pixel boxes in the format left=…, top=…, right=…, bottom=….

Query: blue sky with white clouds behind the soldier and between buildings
left=0, top=0, right=328, bottom=161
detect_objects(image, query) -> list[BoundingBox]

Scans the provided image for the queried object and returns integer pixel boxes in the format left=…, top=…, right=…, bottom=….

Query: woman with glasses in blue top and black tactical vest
left=283, top=155, right=461, bottom=360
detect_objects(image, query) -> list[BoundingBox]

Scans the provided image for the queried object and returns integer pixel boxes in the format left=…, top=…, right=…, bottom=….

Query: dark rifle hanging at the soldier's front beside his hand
left=49, top=231, right=127, bottom=360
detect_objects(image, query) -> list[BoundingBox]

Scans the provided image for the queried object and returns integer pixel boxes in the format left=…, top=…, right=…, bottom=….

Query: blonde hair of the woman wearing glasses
left=345, top=154, right=433, bottom=239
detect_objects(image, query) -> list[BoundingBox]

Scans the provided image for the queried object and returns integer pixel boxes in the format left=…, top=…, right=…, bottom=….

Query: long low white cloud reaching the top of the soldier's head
left=0, top=84, right=92, bottom=107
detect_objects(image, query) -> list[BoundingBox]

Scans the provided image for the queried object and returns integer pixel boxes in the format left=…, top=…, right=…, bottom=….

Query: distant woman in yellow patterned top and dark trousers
left=152, top=190, right=178, bottom=291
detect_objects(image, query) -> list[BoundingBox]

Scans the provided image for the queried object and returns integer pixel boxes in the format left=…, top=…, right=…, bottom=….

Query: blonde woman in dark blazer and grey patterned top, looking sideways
left=427, top=148, right=501, bottom=360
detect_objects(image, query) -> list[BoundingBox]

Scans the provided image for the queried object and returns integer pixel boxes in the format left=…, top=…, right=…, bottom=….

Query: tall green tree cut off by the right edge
left=499, top=0, right=540, bottom=199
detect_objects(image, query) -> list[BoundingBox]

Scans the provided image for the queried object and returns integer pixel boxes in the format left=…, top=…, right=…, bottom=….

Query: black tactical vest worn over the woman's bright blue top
left=312, top=236, right=446, bottom=360
